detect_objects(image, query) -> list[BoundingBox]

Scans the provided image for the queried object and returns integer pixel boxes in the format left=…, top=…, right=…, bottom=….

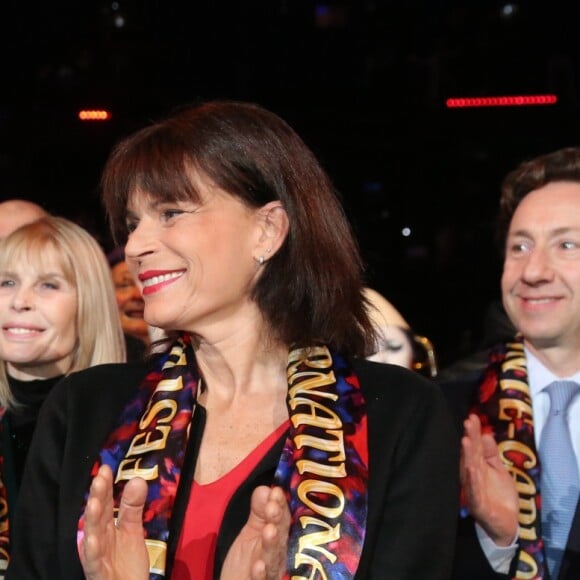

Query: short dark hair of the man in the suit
left=496, top=147, right=580, bottom=253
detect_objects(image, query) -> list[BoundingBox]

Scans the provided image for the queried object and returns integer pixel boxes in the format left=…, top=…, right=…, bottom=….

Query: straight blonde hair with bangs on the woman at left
left=0, top=216, right=126, bottom=407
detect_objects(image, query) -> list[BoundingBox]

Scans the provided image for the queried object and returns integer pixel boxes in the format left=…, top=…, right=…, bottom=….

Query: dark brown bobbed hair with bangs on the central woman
left=101, top=101, right=374, bottom=356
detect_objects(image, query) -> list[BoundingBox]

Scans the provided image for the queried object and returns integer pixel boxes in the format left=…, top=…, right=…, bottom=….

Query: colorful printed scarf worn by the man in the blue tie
left=462, top=335, right=546, bottom=580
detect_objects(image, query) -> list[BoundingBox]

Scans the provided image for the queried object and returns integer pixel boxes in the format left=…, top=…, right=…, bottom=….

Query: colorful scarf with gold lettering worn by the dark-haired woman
left=78, top=335, right=368, bottom=580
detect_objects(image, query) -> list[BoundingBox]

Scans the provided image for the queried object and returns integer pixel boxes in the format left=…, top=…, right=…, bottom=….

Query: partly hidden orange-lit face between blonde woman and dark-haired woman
left=111, top=261, right=149, bottom=342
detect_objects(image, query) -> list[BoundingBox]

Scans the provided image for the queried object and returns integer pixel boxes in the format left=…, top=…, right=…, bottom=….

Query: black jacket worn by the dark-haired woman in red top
left=7, top=360, right=459, bottom=580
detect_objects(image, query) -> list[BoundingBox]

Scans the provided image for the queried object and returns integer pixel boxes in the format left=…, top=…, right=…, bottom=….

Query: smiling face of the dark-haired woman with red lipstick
left=125, top=180, right=261, bottom=340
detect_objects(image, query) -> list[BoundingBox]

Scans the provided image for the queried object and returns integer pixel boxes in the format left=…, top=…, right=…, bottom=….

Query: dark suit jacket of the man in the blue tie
left=440, top=367, right=580, bottom=580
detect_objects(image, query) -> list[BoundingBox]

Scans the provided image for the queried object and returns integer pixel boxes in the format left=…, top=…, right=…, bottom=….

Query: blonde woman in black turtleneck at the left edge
left=0, top=216, right=125, bottom=571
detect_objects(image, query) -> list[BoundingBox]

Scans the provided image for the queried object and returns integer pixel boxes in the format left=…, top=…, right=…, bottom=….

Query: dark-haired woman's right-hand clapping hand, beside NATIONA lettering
left=220, top=486, right=290, bottom=580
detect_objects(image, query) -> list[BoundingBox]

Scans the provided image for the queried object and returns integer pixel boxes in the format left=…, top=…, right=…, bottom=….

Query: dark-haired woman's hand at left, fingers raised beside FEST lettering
left=80, top=465, right=149, bottom=580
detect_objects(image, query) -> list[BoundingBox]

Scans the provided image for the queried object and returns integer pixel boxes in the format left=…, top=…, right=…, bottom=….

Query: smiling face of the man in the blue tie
left=501, top=181, right=580, bottom=350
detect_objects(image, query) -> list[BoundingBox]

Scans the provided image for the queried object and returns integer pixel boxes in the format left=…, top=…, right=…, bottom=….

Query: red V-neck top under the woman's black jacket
left=171, top=420, right=289, bottom=580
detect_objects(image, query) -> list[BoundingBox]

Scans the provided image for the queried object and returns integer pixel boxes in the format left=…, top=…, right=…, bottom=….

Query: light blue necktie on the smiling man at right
left=540, top=381, right=580, bottom=579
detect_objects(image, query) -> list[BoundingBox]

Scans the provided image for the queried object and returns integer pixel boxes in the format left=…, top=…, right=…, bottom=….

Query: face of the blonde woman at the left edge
left=0, top=250, right=78, bottom=380
